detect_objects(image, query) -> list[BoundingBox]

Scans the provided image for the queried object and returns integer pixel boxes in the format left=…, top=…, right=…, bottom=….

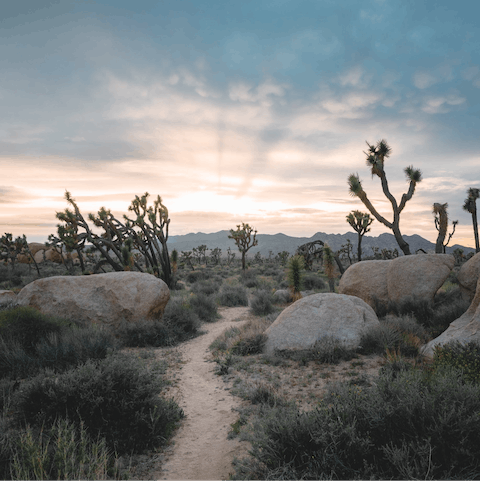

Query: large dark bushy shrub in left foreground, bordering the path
left=15, top=355, right=183, bottom=454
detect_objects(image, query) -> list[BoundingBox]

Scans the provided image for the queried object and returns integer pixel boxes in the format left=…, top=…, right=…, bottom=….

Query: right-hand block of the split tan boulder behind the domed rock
left=387, top=254, right=455, bottom=302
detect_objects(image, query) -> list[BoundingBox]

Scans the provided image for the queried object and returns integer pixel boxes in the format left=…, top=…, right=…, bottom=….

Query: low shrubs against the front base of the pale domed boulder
left=275, top=336, right=355, bottom=364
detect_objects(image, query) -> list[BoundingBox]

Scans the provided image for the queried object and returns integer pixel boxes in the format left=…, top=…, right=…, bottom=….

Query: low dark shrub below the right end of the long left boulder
left=116, top=319, right=172, bottom=347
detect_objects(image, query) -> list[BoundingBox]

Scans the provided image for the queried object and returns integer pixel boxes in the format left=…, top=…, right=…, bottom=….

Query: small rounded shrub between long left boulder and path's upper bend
left=162, top=297, right=201, bottom=343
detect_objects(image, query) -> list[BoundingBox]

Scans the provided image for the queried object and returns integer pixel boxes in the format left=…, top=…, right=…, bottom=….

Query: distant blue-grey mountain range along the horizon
left=168, top=230, right=475, bottom=257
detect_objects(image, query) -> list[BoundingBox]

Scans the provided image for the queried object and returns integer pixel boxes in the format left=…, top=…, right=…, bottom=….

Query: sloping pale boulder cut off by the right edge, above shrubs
left=421, top=279, right=480, bottom=358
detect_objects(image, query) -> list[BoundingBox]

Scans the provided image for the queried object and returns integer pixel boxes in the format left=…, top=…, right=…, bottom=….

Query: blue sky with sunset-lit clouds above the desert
left=0, top=0, right=480, bottom=247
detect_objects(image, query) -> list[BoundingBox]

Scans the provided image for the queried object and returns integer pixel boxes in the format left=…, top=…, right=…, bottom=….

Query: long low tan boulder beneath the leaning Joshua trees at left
left=17, top=272, right=170, bottom=326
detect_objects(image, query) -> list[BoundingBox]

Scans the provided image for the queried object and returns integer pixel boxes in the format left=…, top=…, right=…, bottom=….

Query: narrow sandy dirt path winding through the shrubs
left=153, top=307, right=250, bottom=481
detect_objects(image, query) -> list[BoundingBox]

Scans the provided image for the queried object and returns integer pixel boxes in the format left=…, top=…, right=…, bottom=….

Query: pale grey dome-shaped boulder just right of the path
left=265, top=293, right=379, bottom=354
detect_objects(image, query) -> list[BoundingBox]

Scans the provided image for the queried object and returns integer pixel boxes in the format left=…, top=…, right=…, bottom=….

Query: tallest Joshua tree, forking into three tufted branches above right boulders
left=348, top=140, right=422, bottom=255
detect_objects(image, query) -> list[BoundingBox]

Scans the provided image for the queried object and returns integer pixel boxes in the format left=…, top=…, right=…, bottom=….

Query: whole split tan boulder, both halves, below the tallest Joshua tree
left=338, top=254, right=455, bottom=306
